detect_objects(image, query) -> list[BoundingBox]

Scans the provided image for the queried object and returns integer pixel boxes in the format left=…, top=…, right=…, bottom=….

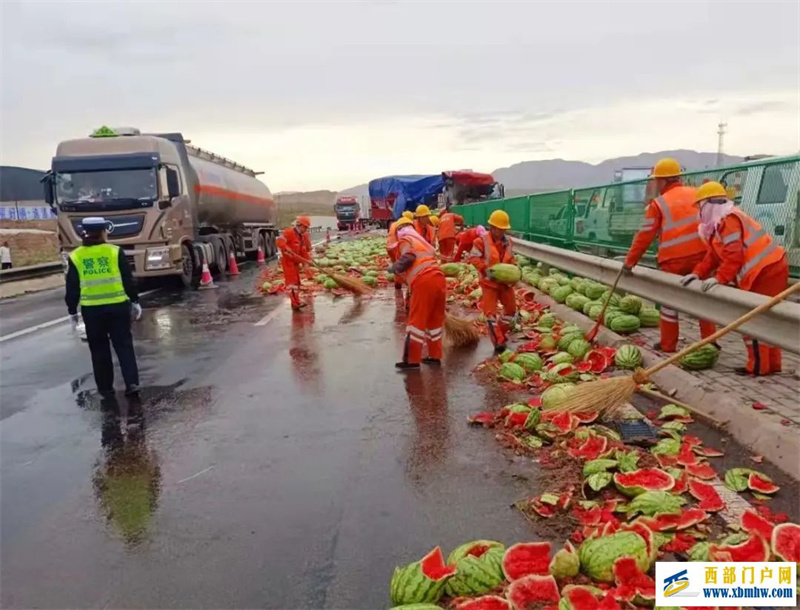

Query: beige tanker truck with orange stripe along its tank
left=43, top=127, right=278, bottom=287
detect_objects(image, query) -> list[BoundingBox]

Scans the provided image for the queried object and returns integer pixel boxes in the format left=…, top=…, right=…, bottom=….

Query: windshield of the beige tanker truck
left=56, top=168, right=158, bottom=207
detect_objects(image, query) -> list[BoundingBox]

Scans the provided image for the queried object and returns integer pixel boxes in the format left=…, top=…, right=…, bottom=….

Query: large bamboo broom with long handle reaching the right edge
left=549, top=283, right=800, bottom=414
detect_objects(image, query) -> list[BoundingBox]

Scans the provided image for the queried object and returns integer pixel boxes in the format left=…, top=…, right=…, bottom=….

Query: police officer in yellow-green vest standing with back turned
left=64, top=217, right=142, bottom=398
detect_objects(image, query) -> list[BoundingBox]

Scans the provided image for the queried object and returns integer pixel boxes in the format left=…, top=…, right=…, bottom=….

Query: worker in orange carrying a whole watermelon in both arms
left=469, top=210, right=517, bottom=353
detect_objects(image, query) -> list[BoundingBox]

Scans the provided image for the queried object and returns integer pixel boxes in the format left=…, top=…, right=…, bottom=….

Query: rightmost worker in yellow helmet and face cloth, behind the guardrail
left=681, top=182, right=789, bottom=375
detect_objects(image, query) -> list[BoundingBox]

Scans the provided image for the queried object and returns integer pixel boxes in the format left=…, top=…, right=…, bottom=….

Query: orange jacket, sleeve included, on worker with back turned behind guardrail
left=625, top=185, right=706, bottom=267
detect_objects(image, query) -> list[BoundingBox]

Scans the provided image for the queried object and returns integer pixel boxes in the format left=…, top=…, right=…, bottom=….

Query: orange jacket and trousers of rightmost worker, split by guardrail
left=692, top=204, right=789, bottom=375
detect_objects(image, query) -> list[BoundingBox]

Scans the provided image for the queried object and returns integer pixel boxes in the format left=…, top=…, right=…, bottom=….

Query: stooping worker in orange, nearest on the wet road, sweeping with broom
left=392, top=218, right=447, bottom=371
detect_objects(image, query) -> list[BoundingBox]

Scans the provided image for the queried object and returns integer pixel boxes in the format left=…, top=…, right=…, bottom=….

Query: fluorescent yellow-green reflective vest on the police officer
left=69, top=244, right=128, bottom=307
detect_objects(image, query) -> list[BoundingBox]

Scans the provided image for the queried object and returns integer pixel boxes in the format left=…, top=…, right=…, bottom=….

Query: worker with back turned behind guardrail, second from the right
left=623, top=158, right=716, bottom=352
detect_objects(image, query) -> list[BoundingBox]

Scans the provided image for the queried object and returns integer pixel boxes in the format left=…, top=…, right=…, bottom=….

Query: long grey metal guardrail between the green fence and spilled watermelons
left=514, top=239, right=800, bottom=354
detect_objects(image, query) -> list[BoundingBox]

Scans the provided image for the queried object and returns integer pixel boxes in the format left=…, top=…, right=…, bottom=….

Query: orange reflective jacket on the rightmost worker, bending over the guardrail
left=694, top=208, right=786, bottom=290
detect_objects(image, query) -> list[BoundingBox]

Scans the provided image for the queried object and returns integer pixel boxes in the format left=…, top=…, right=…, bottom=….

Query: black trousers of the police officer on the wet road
left=81, top=302, right=139, bottom=394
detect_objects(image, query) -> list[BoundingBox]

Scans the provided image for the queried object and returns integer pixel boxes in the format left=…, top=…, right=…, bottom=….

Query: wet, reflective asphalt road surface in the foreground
left=0, top=264, right=535, bottom=608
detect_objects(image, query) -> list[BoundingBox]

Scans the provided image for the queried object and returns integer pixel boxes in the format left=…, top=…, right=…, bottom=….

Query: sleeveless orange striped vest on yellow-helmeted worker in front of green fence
left=642, top=186, right=706, bottom=263
